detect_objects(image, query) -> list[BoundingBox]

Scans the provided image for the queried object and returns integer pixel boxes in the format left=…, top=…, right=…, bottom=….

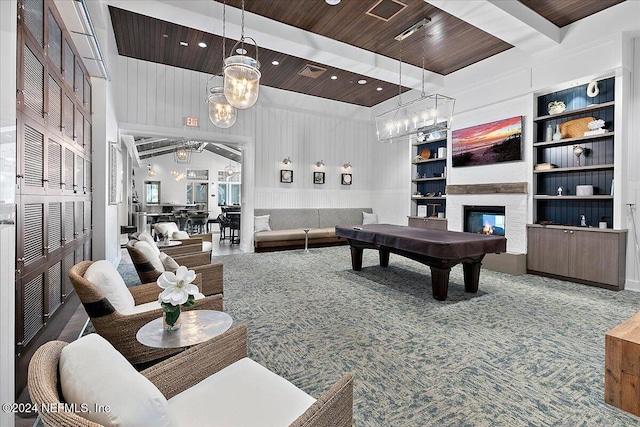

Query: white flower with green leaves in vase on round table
left=157, top=265, right=199, bottom=326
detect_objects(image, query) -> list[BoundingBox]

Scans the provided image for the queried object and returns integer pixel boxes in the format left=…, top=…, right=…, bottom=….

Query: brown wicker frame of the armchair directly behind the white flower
left=69, top=261, right=222, bottom=365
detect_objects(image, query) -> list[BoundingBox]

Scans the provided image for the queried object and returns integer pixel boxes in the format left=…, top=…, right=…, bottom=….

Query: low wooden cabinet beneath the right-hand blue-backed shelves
left=527, top=225, right=627, bottom=290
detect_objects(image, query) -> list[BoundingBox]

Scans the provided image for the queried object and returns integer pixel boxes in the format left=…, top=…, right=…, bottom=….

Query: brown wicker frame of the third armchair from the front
left=126, top=240, right=223, bottom=295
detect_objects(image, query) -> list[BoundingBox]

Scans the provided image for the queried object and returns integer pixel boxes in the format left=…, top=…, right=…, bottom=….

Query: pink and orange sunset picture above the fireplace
left=451, top=116, right=522, bottom=167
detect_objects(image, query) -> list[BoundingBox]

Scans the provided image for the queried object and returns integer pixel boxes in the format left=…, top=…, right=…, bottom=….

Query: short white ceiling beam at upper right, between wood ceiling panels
left=424, top=0, right=564, bottom=53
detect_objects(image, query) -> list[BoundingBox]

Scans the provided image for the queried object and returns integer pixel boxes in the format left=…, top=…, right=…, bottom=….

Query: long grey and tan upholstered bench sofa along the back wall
left=253, top=208, right=377, bottom=252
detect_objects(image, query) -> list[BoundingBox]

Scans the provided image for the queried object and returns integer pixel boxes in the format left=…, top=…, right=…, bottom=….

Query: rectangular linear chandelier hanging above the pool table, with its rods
left=376, top=18, right=455, bottom=143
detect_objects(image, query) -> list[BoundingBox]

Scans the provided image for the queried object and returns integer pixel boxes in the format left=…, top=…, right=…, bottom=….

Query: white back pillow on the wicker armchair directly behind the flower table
left=84, top=260, right=136, bottom=314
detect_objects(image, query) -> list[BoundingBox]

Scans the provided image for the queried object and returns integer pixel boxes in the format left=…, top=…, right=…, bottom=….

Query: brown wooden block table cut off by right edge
left=604, top=312, right=640, bottom=416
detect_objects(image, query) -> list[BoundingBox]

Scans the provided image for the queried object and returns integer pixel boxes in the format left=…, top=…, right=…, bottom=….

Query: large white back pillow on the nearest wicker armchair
left=59, top=334, right=178, bottom=427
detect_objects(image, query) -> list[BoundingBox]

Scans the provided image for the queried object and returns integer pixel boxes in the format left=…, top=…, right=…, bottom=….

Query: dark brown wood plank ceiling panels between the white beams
left=109, top=0, right=624, bottom=107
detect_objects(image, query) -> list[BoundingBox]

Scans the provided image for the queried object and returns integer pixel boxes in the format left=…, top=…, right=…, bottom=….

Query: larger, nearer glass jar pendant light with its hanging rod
left=223, top=0, right=261, bottom=110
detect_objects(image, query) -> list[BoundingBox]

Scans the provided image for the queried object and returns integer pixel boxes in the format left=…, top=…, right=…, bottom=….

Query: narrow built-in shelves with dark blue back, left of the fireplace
left=411, top=134, right=447, bottom=218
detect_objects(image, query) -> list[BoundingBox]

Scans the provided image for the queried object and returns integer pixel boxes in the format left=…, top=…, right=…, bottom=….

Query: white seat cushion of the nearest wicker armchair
left=169, top=357, right=316, bottom=427
